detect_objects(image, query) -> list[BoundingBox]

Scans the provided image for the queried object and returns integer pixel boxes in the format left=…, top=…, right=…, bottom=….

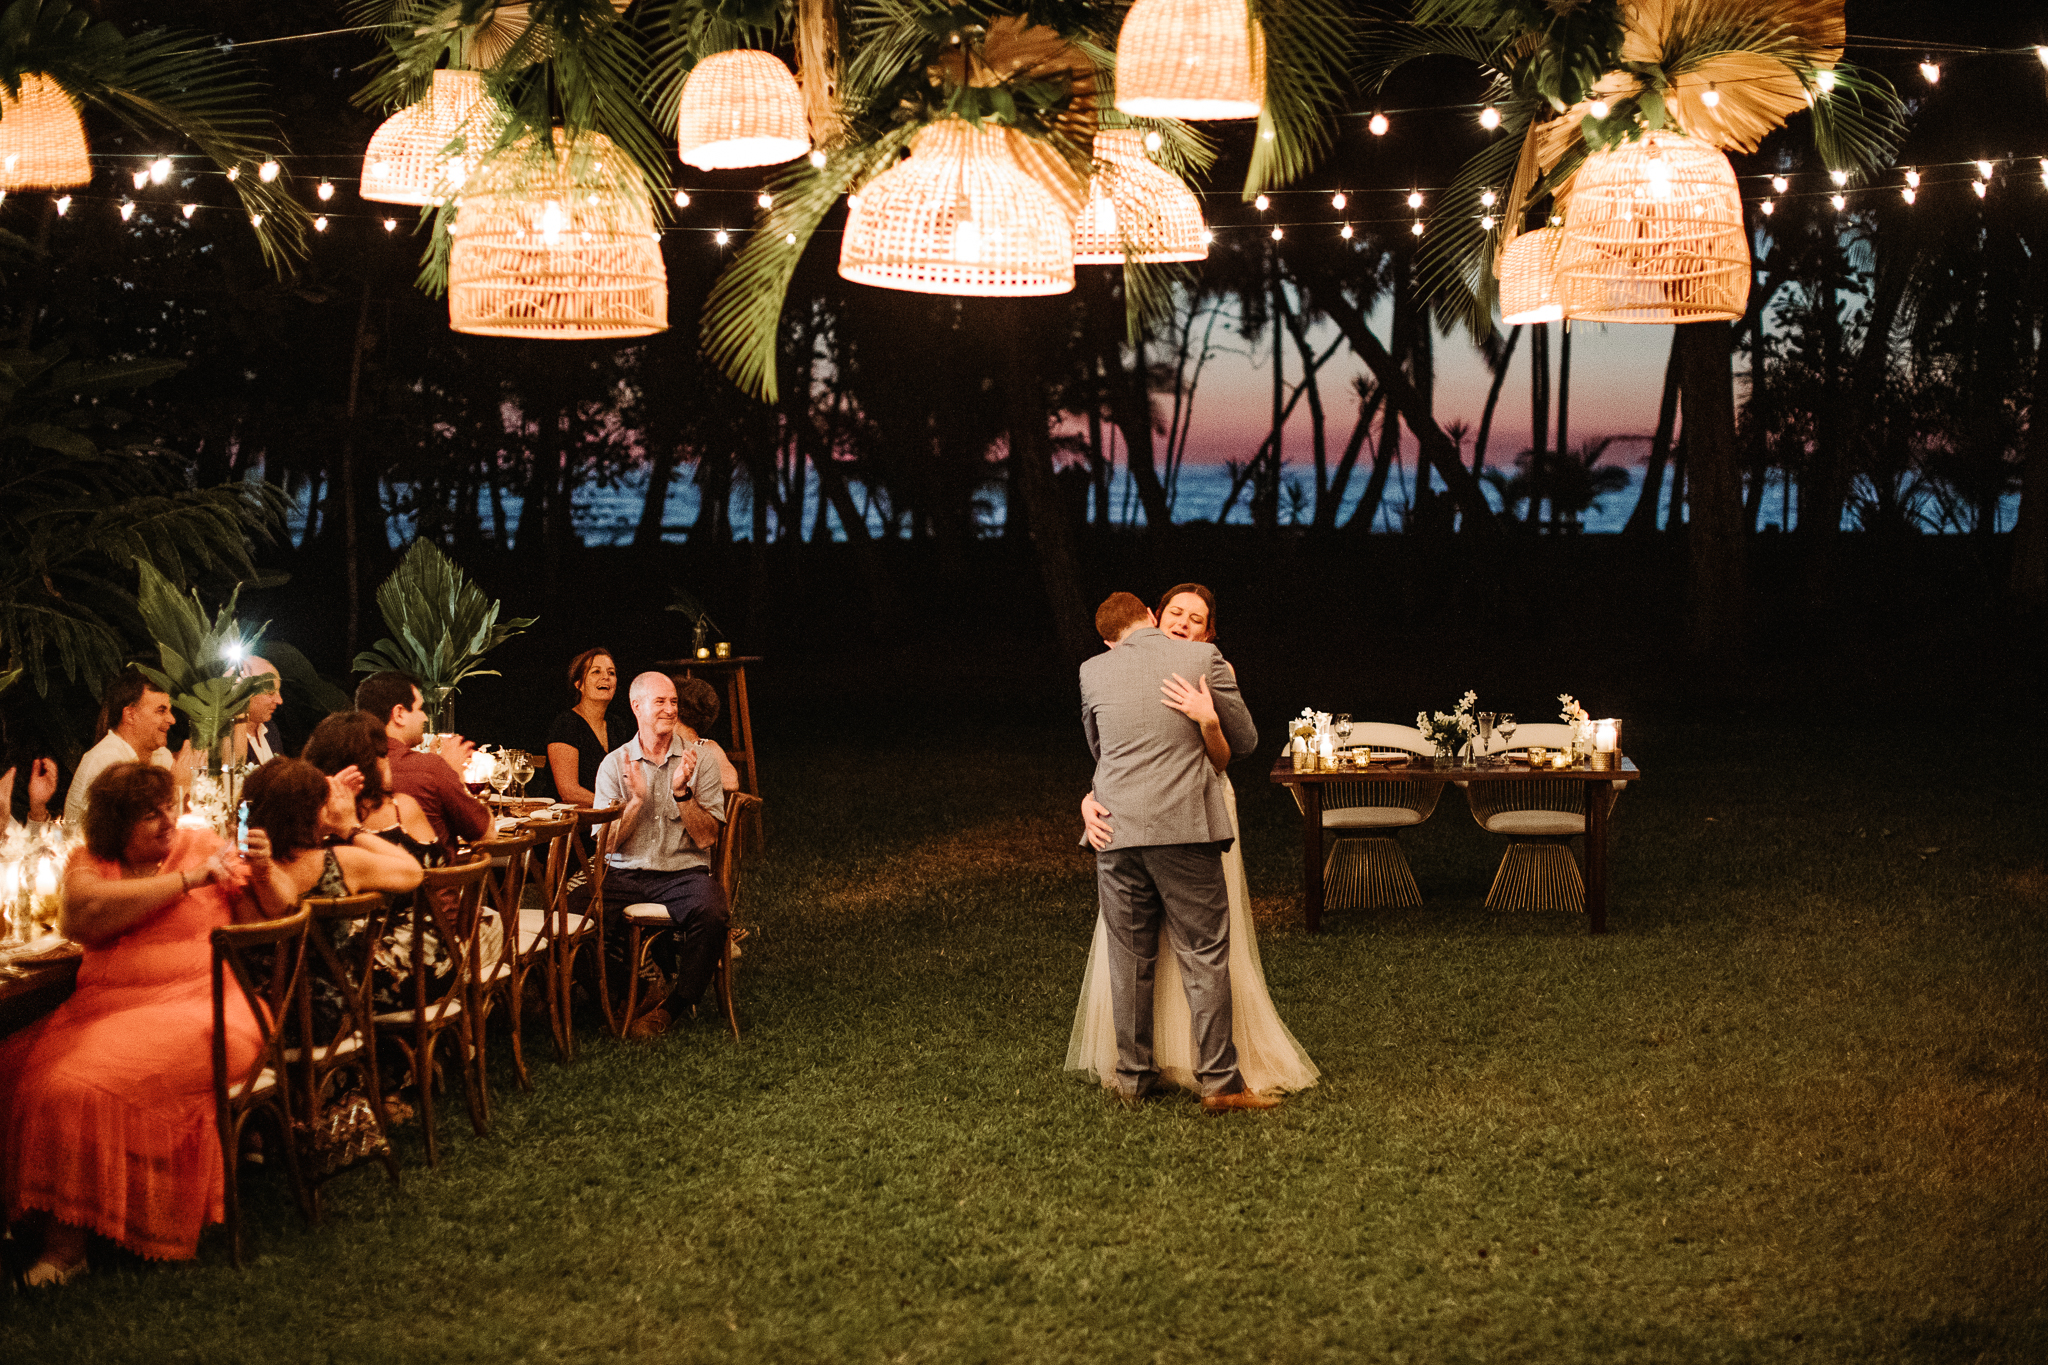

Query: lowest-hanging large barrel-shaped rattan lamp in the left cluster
left=449, top=129, right=668, bottom=342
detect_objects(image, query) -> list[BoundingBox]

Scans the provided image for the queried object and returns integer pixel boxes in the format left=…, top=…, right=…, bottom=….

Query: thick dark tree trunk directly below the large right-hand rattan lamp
left=1677, top=321, right=1749, bottom=659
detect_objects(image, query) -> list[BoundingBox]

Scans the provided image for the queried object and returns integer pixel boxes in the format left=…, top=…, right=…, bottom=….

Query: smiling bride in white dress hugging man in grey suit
left=1067, top=583, right=1319, bottom=1093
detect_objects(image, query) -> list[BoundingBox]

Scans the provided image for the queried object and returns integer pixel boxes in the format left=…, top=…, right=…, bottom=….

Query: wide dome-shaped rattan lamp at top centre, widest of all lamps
left=840, top=119, right=1073, bottom=297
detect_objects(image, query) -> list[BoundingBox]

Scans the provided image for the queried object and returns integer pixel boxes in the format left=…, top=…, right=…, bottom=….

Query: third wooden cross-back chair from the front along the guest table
left=377, top=851, right=492, bottom=1166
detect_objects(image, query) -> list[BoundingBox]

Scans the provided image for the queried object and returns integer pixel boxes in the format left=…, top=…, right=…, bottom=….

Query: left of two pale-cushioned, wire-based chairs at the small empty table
left=1288, top=720, right=1444, bottom=909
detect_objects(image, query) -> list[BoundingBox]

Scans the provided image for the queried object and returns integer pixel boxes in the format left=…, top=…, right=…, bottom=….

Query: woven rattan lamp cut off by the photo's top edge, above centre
left=1116, top=0, right=1266, bottom=119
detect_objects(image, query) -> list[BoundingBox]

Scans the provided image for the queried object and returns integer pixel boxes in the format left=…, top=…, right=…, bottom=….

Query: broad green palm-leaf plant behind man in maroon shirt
left=352, top=540, right=539, bottom=731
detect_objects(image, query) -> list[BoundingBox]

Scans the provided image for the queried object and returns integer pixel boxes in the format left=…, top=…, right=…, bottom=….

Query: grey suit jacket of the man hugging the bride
left=1081, top=628, right=1260, bottom=849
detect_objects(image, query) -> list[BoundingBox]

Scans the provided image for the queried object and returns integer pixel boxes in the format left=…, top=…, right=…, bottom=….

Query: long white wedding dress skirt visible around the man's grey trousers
left=1067, top=772, right=1321, bottom=1093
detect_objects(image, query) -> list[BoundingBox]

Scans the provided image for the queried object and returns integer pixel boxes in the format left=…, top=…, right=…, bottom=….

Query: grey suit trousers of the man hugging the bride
left=1096, top=843, right=1245, bottom=1095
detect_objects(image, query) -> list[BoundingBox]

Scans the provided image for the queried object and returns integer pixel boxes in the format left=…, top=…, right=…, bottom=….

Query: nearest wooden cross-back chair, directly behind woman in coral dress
left=209, top=909, right=309, bottom=1269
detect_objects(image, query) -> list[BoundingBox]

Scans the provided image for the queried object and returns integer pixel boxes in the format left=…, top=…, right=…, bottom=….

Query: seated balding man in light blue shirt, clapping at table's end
left=577, top=673, right=731, bottom=1038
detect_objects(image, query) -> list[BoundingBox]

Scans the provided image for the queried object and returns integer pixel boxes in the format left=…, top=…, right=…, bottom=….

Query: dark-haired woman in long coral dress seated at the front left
left=0, top=763, right=260, bottom=1285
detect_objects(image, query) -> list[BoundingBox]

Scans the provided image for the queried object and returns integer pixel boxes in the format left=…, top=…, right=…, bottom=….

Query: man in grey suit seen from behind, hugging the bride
left=1081, top=593, right=1280, bottom=1113
